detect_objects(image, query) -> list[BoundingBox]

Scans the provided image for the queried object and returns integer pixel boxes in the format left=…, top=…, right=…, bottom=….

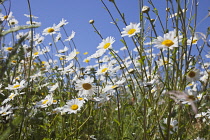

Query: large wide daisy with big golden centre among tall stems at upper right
left=153, top=30, right=179, bottom=49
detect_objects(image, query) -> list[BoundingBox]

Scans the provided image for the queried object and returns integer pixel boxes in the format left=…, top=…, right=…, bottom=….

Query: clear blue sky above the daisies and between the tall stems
left=1, top=0, right=210, bottom=54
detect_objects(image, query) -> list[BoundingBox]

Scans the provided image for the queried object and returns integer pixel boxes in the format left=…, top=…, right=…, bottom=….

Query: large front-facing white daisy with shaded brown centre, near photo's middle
left=75, top=77, right=96, bottom=98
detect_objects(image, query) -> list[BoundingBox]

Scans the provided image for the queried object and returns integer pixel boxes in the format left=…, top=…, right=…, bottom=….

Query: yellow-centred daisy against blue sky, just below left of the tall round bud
left=121, top=23, right=141, bottom=37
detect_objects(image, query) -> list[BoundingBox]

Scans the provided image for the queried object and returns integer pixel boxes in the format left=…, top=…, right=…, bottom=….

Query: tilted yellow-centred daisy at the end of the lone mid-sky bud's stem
left=97, top=36, right=115, bottom=50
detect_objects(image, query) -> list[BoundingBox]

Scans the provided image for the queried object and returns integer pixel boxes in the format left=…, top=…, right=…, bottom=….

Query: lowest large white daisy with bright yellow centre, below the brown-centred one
left=63, top=99, right=84, bottom=114
